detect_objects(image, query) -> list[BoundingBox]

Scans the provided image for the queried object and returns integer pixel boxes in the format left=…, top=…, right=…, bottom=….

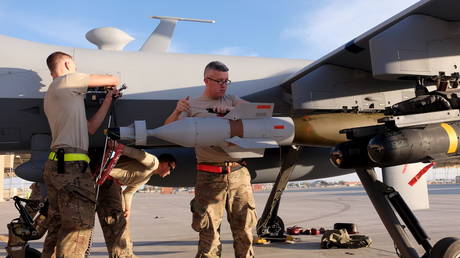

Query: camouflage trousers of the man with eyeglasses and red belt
left=191, top=167, right=257, bottom=258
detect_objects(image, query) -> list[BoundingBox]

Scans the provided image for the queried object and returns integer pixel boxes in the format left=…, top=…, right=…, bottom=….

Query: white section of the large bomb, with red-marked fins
left=116, top=103, right=295, bottom=158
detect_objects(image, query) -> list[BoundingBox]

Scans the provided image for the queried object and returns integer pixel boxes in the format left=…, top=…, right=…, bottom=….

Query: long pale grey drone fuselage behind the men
left=0, top=35, right=351, bottom=186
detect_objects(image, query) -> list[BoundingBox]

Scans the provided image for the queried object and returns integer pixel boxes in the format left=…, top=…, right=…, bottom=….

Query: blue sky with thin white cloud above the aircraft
left=0, top=0, right=424, bottom=180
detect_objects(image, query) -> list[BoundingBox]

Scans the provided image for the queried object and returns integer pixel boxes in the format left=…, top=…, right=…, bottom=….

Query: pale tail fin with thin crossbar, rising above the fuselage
left=139, top=16, right=214, bottom=53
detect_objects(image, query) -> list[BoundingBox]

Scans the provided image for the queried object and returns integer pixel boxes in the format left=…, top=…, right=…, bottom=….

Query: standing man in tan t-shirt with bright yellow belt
left=43, top=52, right=120, bottom=257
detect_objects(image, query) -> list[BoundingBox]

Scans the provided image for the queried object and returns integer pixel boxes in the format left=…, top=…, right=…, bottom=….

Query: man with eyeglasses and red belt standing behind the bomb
left=165, top=61, right=257, bottom=257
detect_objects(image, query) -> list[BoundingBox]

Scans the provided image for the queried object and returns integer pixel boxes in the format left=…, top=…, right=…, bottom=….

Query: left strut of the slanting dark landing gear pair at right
left=356, top=168, right=419, bottom=258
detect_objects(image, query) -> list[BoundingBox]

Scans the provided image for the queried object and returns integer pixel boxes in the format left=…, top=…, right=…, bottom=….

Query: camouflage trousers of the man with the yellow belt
left=42, top=160, right=96, bottom=258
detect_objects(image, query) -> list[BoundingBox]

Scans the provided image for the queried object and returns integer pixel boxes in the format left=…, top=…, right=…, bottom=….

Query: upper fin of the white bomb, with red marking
left=224, top=103, right=274, bottom=120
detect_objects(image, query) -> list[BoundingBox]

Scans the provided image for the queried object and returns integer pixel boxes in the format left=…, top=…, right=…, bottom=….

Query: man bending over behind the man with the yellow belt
left=96, top=143, right=176, bottom=258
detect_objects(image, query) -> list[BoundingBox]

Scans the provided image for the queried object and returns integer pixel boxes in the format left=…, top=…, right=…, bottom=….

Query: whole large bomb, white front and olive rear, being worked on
left=106, top=103, right=383, bottom=158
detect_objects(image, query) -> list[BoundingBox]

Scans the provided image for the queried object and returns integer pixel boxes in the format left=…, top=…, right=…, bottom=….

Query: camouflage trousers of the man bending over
left=96, top=180, right=135, bottom=258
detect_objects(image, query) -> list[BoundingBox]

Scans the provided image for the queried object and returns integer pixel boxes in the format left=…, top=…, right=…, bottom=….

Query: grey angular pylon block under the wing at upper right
left=369, top=15, right=460, bottom=80
